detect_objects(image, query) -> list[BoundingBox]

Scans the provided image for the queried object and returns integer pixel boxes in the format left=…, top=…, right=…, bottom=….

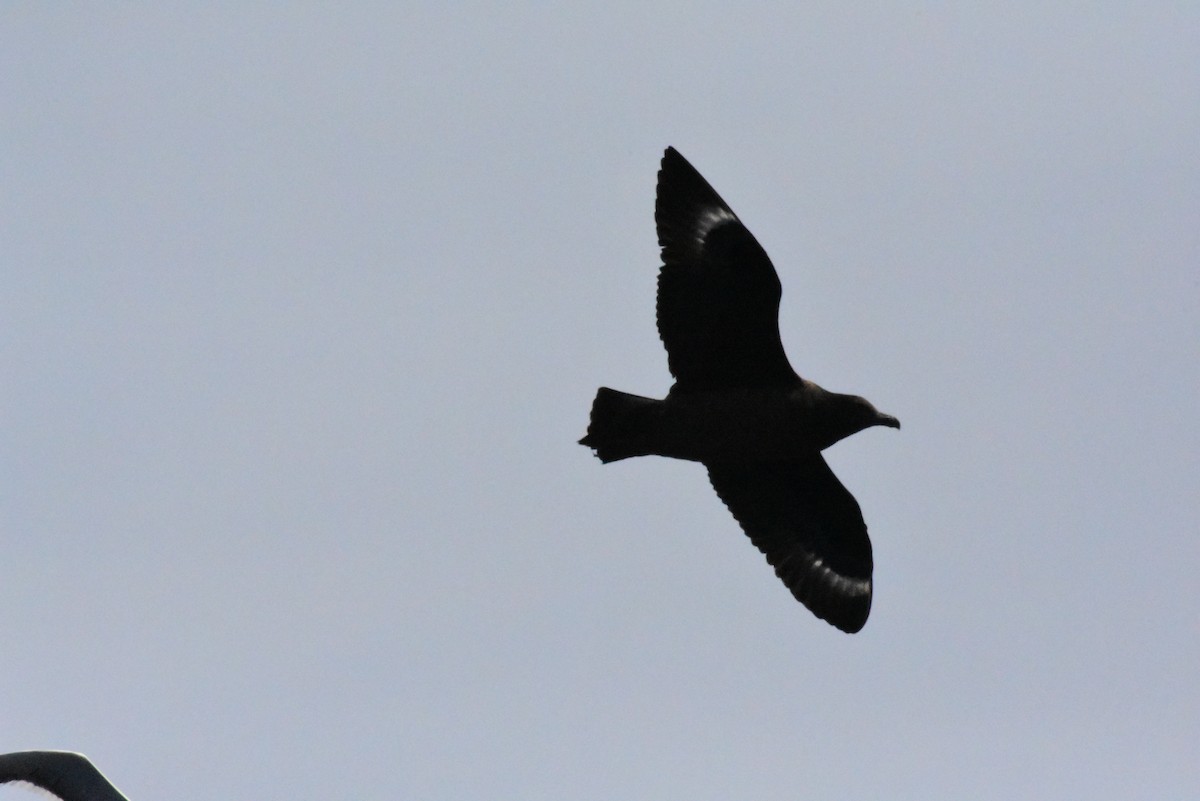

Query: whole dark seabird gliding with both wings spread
left=580, top=147, right=900, bottom=633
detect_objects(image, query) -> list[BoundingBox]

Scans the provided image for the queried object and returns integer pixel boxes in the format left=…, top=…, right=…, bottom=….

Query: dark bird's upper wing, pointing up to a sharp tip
left=654, top=147, right=798, bottom=390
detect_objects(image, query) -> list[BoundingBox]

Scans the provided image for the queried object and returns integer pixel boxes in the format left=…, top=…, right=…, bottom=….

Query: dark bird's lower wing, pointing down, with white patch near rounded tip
left=706, top=453, right=872, bottom=633
